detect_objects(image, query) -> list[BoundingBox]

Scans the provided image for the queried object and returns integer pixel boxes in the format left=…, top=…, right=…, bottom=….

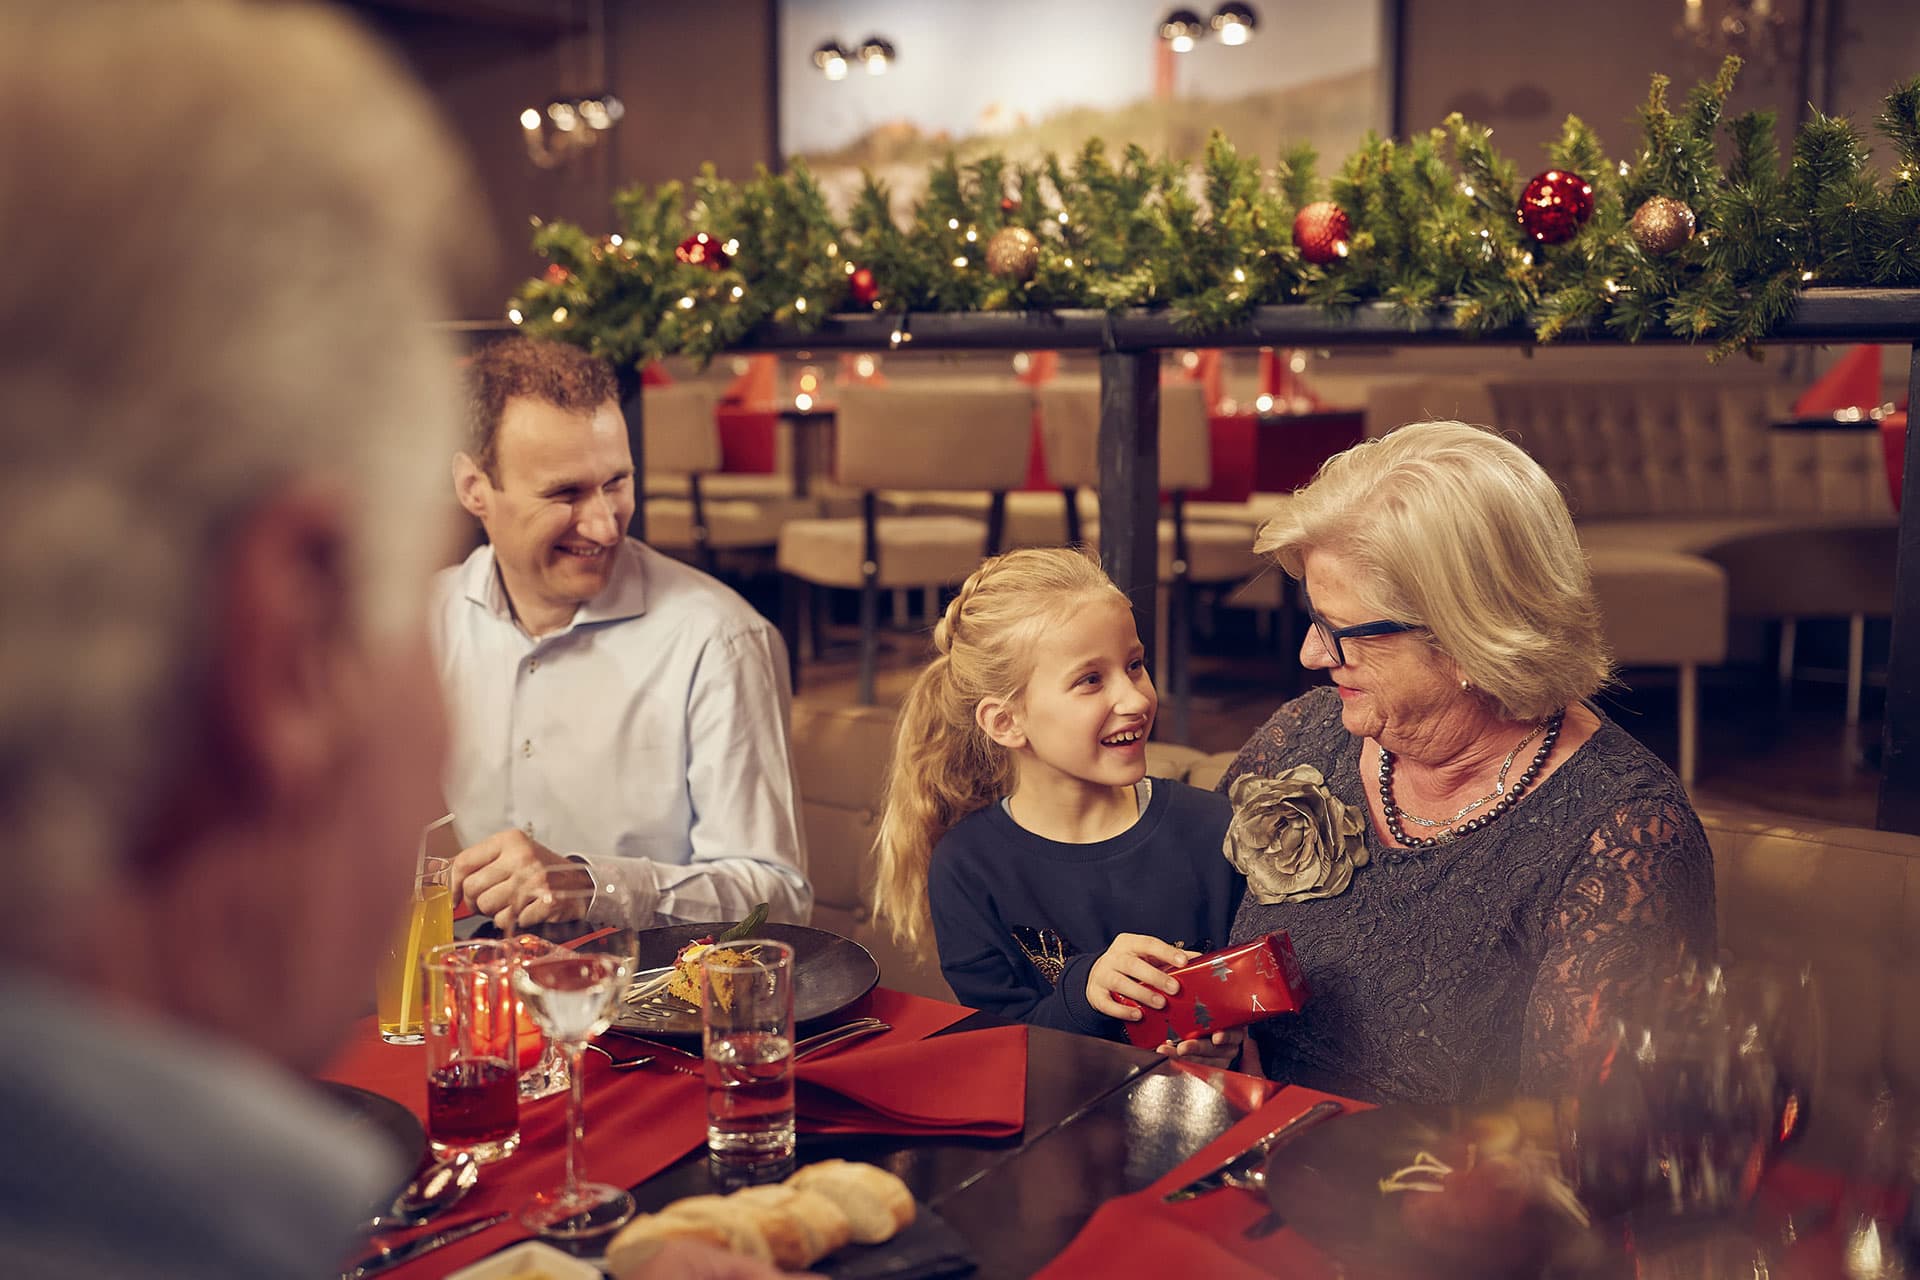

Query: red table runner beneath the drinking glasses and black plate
left=319, top=986, right=975, bottom=1280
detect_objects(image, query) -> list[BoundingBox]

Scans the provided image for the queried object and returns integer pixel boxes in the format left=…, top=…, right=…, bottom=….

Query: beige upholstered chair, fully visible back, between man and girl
left=776, top=384, right=1033, bottom=706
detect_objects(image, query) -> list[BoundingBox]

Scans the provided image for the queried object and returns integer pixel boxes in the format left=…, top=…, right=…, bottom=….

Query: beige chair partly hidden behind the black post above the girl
left=1039, top=380, right=1263, bottom=743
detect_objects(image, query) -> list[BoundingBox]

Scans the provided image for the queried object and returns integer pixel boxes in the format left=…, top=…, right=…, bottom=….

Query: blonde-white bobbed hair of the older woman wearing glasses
left=1254, top=422, right=1613, bottom=720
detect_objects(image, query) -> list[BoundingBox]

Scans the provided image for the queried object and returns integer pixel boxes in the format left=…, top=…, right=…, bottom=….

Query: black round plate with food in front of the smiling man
left=612, top=921, right=879, bottom=1036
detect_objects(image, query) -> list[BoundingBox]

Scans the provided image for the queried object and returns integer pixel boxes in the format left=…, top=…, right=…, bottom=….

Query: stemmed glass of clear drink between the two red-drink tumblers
left=513, top=865, right=634, bottom=1240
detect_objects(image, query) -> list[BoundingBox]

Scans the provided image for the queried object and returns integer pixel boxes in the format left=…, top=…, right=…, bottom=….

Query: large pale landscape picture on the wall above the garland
left=776, top=0, right=1398, bottom=203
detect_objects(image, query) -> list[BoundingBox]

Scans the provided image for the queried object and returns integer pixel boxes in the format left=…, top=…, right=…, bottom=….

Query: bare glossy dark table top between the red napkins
left=634, top=1013, right=1242, bottom=1280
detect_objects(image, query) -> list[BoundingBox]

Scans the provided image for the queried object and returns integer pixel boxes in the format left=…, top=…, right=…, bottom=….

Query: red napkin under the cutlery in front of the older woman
left=1035, top=1086, right=1361, bottom=1280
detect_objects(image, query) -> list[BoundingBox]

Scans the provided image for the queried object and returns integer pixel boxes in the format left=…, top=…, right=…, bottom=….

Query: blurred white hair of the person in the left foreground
left=0, top=0, right=472, bottom=902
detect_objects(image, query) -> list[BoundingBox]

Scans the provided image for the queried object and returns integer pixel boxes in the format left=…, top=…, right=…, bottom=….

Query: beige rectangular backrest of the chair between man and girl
left=833, top=384, right=1033, bottom=491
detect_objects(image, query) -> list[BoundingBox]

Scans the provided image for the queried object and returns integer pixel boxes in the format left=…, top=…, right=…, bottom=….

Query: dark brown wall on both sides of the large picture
left=337, top=0, right=1920, bottom=319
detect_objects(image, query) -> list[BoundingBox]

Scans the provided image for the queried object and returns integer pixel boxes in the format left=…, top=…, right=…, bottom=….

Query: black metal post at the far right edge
left=1874, top=342, right=1920, bottom=833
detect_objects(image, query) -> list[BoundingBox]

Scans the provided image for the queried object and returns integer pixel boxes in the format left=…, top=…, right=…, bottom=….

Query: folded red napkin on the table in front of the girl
left=793, top=1025, right=1027, bottom=1138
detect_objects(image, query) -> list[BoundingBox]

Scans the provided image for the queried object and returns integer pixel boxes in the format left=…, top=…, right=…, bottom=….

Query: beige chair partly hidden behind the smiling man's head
left=643, top=382, right=818, bottom=574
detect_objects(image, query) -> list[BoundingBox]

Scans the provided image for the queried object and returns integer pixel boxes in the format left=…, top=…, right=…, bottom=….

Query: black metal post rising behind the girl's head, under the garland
left=1100, top=351, right=1162, bottom=676
